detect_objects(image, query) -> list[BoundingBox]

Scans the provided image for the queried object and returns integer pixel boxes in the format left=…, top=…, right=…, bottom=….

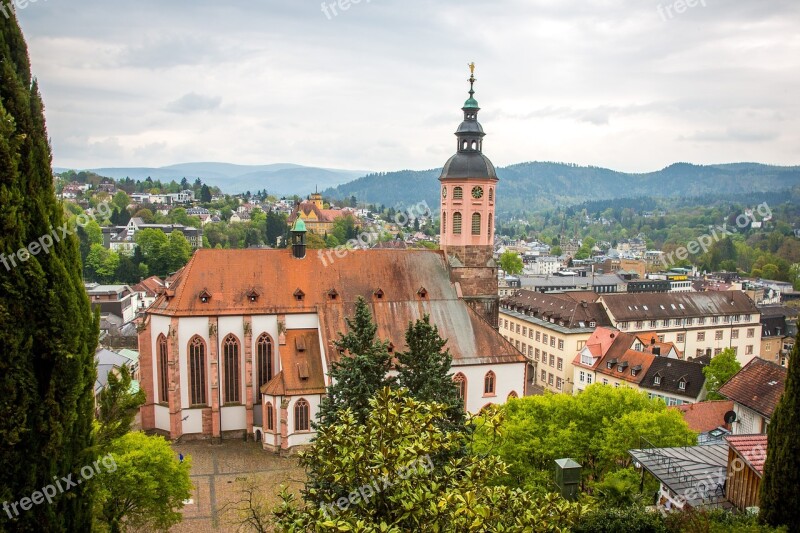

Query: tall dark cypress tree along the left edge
left=0, top=8, right=98, bottom=531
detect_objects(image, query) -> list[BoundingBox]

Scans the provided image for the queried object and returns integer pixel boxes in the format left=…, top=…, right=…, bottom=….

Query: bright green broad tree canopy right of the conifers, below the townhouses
left=480, top=384, right=696, bottom=488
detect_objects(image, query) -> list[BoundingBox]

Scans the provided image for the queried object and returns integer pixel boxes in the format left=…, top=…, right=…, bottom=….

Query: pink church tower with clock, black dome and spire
left=439, top=63, right=500, bottom=327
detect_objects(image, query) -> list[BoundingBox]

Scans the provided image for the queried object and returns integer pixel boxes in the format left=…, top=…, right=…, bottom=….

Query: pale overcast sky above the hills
left=18, top=0, right=800, bottom=172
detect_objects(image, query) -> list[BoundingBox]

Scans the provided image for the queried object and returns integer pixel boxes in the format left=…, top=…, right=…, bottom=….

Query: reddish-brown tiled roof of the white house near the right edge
left=719, top=357, right=786, bottom=418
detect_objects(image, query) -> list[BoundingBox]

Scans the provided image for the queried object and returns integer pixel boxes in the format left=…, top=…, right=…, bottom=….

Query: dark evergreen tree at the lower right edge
left=759, top=320, right=800, bottom=531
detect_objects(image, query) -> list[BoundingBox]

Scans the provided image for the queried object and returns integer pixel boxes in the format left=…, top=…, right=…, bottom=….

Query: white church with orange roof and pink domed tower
left=139, top=66, right=527, bottom=452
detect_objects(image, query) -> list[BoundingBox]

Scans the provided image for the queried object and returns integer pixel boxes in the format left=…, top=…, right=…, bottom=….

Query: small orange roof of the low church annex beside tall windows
left=261, top=329, right=325, bottom=396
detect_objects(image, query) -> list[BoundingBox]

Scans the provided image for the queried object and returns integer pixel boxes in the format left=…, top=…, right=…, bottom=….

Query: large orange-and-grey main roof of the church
left=148, top=248, right=526, bottom=366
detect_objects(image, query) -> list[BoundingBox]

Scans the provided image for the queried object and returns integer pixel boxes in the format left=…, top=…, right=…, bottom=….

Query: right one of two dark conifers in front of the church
left=397, top=315, right=466, bottom=429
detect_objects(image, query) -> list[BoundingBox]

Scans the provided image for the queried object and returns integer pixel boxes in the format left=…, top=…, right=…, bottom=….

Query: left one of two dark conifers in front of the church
left=317, top=297, right=394, bottom=427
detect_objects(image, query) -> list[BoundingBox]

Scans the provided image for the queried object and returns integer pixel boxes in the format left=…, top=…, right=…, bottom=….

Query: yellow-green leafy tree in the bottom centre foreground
left=276, top=388, right=585, bottom=533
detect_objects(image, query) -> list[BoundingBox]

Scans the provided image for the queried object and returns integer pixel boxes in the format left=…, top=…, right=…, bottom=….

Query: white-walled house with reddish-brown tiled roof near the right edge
left=719, top=358, right=787, bottom=435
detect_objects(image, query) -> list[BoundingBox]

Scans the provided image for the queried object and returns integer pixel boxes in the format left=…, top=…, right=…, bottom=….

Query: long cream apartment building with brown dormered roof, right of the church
left=598, top=291, right=762, bottom=365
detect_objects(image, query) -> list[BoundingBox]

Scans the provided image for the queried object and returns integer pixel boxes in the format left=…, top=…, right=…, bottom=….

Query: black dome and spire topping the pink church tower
left=439, top=65, right=497, bottom=180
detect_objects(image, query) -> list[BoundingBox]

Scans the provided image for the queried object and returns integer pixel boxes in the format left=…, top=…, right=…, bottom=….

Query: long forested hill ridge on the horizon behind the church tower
left=324, top=162, right=800, bottom=216
